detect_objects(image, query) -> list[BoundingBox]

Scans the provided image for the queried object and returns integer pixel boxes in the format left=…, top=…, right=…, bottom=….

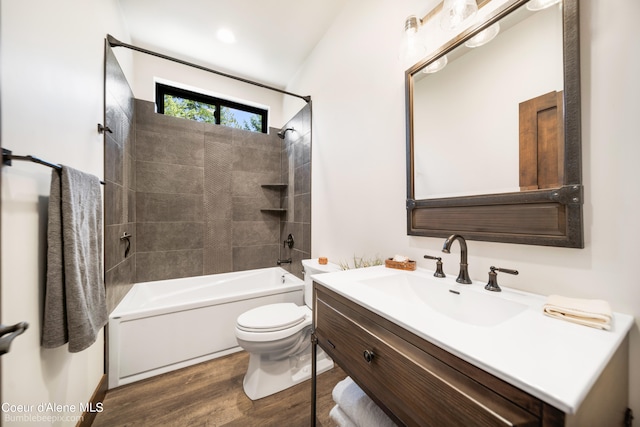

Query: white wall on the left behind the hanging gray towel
left=0, top=0, right=130, bottom=425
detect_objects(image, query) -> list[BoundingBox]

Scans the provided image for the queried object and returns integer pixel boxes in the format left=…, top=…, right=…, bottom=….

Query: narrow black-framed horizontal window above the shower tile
left=156, top=83, right=267, bottom=133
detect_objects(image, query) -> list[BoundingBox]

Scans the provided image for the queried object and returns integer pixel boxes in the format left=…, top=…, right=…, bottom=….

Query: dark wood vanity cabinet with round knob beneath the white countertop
left=312, top=282, right=628, bottom=427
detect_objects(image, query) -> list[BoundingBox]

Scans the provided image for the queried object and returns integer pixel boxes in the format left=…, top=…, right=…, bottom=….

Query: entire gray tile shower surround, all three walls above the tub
left=105, top=47, right=311, bottom=311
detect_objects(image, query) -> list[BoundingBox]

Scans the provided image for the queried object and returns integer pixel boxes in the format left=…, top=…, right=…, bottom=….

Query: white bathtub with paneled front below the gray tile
left=108, top=267, right=304, bottom=388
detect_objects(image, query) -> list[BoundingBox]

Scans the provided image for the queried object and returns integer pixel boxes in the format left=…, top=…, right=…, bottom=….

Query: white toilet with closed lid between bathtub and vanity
left=236, top=259, right=341, bottom=400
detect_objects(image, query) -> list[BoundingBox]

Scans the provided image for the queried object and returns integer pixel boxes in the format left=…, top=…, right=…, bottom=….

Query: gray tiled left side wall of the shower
left=104, top=46, right=136, bottom=312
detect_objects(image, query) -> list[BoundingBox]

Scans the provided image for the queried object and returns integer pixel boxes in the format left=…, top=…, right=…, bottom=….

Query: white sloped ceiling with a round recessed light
left=119, top=0, right=347, bottom=88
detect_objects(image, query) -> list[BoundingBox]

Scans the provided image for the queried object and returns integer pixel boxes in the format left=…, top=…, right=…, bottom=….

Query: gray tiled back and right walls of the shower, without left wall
left=136, top=100, right=310, bottom=282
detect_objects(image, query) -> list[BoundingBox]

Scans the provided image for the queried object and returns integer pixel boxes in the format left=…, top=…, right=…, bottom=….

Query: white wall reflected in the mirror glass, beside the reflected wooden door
left=413, top=5, right=563, bottom=199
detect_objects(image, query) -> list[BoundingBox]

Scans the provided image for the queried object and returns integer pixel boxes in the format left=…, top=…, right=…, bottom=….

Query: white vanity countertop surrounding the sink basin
left=312, top=266, right=634, bottom=414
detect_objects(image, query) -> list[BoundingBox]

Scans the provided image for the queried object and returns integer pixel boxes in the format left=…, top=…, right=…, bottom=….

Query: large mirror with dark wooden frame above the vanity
left=406, top=0, right=584, bottom=248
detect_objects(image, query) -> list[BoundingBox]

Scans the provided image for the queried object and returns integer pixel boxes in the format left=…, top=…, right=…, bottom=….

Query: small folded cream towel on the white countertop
left=543, top=295, right=612, bottom=330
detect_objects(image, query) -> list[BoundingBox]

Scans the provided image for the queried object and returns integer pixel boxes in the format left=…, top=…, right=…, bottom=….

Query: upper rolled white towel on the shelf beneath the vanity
left=331, top=377, right=396, bottom=427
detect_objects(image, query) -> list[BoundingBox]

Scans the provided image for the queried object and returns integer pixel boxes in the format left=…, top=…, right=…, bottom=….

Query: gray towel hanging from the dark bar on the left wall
left=42, top=166, right=108, bottom=353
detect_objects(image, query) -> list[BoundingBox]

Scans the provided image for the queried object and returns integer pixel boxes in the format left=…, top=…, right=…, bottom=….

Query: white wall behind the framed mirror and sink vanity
left=289, top=0, right=640, bottom=414
